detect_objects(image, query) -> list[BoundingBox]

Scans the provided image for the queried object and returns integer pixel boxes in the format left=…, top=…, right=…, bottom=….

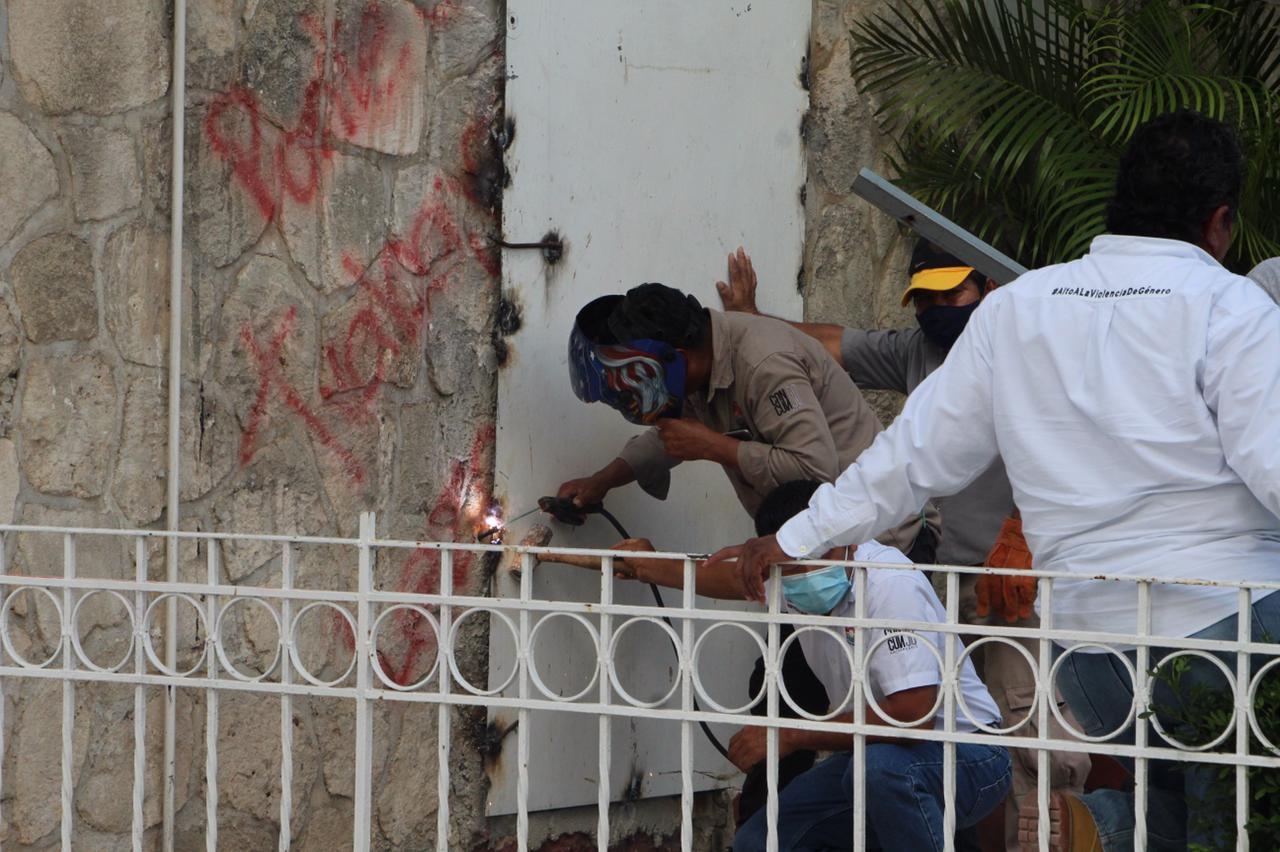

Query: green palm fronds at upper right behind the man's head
left=850, top=0, right=1280, bottom=267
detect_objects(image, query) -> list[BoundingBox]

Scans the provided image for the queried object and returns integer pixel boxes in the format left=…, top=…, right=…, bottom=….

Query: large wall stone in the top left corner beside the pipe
left=9, top=0, right=170, bottom=115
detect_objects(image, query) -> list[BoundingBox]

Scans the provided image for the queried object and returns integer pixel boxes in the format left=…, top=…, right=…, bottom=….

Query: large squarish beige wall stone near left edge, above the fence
left=18, top=354, right=118, bottom=498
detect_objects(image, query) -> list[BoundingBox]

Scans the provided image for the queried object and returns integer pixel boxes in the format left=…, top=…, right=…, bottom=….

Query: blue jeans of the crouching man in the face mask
left=733, top=742, right=1011, bottom=852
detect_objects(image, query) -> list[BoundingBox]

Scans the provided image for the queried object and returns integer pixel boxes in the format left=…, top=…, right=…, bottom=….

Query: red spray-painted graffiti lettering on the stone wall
left=211, top=0, right=500, bottom=683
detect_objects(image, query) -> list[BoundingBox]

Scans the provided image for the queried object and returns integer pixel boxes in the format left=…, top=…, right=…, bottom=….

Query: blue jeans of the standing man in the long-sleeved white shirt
left=1053, top=594, right=1280, bottom=852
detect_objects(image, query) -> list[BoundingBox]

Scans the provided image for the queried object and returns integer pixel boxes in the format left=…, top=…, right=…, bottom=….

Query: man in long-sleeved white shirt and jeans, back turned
left=710, top=111, right=1280, bottom=851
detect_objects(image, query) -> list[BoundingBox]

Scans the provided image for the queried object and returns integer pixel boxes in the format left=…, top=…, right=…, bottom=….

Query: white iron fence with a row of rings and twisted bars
left=0, top=514, right=1280, bottom=849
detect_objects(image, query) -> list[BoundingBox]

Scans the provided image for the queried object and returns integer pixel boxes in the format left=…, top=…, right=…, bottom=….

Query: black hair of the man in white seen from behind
left=1107, top=110, right=1244, bottom=244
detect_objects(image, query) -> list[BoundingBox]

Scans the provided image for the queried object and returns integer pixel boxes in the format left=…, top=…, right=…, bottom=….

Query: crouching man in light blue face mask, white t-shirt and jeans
left=555, top=481, right=1011, bottom=852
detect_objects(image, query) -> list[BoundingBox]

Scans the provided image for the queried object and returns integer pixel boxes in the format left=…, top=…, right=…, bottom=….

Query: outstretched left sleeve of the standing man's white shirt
left=777, top=300, right=1000, bottom=558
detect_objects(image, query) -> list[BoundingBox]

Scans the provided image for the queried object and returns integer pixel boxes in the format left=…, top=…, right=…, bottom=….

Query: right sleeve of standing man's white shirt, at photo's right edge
left=1203, top=285, right=1280, bottom=516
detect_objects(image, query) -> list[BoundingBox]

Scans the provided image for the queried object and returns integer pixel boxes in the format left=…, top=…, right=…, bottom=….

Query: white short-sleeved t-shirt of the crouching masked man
left=787, top=541, right=1000, bottom=732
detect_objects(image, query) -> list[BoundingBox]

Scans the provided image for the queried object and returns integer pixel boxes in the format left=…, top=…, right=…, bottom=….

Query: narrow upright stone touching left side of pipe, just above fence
left=111, top=370, right=169, bottom=527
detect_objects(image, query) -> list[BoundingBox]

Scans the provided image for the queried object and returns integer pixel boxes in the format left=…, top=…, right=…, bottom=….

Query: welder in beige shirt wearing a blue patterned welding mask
left=558, top=278, right=938, bottom=562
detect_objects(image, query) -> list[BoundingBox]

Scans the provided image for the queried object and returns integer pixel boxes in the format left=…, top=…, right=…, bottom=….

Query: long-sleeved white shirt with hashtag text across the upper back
left=778, top=235, right=1280, bottom=636
